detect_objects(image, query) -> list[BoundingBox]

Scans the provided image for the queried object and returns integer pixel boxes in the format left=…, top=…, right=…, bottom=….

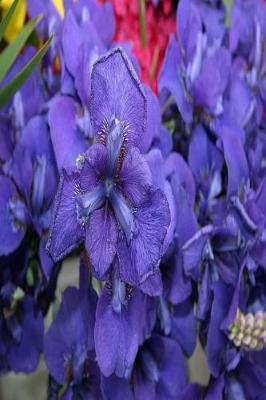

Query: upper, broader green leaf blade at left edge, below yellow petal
left=0, top=16, right=41, bottom=82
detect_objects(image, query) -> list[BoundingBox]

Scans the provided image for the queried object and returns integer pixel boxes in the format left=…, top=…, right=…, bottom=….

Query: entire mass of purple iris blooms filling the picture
left=0, top=0, right=266, bottom=400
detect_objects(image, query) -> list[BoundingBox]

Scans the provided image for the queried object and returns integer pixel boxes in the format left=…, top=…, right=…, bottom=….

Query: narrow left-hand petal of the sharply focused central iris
left=47, top=169, right=84, bottom=262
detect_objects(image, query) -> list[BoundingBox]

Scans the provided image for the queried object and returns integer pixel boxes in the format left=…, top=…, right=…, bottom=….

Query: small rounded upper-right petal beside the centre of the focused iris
left=119, top=147, right=152, bottom=206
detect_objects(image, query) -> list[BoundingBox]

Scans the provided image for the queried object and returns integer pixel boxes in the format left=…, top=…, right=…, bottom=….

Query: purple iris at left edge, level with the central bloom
left=0, top=116, right=57, bottom=276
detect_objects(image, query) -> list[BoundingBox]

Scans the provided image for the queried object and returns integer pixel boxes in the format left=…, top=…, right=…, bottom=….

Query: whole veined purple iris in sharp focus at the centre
left=47, top=49, right=170, bottom=286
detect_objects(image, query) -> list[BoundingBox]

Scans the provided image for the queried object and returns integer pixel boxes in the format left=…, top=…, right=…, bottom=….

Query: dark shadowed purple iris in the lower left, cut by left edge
left=0, top=252, right=44, bottom=373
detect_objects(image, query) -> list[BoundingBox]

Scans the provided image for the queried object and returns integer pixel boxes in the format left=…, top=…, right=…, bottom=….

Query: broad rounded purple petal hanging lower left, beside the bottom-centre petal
left=44, top=287, right=96, bottom=384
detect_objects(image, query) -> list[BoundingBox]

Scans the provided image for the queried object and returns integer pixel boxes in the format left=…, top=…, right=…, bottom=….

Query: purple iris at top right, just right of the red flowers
left=159, top=0, right=231, bottom=123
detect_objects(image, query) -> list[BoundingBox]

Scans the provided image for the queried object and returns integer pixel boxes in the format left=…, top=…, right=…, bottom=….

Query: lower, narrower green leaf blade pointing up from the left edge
left=0, top=36, right=53, bottom=108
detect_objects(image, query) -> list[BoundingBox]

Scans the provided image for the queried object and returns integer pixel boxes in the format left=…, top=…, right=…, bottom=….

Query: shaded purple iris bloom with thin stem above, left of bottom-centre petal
left=44, top=259, right=99, bottom=398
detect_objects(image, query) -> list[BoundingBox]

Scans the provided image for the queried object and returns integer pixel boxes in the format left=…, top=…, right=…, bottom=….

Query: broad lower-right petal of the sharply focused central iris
left=118, top=189, right=170, bottom=285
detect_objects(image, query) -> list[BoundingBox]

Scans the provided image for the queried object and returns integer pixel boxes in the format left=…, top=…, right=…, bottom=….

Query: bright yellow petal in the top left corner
left=0, top=0, right=26, bottom=43
